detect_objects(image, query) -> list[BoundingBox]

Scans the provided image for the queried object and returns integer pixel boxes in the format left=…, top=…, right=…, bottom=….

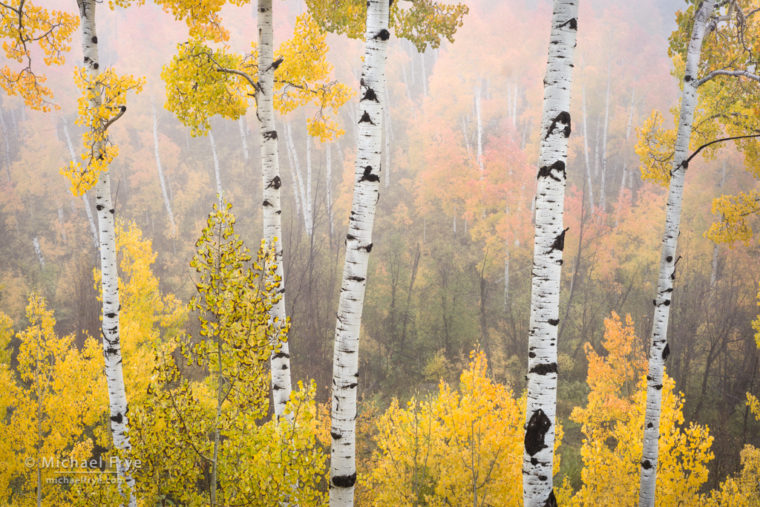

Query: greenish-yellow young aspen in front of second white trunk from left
left=125, top=202, right=325, bottom=505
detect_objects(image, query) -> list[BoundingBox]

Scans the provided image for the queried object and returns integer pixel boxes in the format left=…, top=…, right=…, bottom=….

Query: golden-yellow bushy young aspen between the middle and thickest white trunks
left=359, top=352, right=562, bottom=505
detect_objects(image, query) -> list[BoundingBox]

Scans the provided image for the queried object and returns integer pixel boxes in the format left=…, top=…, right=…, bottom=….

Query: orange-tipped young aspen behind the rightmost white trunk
left=557, top=312, right=713, bottom=505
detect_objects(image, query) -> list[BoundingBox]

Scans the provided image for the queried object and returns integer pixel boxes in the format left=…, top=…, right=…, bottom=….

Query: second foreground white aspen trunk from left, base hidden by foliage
left=257, top=0, right=291, bottom=418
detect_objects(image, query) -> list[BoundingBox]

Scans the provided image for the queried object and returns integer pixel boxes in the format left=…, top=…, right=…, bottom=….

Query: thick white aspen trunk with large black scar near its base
left=522, top=0, right=578, bottom=507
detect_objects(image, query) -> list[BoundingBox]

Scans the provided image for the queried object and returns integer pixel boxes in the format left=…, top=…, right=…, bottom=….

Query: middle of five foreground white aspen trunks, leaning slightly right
left=330, top=0, right=390, bottom=507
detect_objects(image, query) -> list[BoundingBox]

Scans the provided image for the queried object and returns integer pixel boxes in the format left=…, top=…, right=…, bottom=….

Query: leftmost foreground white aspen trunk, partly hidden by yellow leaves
left=77, top=0, right=137, bottom=507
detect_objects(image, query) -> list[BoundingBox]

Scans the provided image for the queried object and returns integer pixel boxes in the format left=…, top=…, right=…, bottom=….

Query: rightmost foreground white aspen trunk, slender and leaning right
left=639, top=0, right=715, bottom=507
